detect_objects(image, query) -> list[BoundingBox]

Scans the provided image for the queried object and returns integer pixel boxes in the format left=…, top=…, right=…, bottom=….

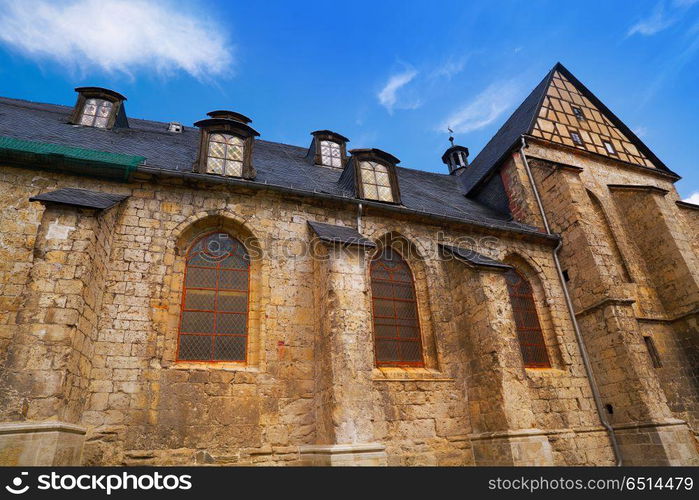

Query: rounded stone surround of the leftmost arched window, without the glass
left=159, top=210, right=269, bottom=372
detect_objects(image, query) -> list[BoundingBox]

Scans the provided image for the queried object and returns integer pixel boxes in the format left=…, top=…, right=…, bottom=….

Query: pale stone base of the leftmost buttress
left=0, top=422, right=85, bottom=466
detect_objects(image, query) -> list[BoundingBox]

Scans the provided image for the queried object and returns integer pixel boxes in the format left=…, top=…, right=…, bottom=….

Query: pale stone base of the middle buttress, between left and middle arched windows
left=299, top=443, right=387, bottom=467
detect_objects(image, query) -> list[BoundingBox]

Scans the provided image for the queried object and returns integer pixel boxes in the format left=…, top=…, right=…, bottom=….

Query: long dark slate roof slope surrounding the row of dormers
left=0, top=98, right=539, bottom=239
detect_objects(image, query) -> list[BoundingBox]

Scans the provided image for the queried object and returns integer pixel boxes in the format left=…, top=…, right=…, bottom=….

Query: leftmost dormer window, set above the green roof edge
left=70, top=87, right=129, bottom=129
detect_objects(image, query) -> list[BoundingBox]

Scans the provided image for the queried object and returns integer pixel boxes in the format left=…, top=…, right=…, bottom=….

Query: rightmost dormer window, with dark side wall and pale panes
left=338, top=149, right=400, bottom=203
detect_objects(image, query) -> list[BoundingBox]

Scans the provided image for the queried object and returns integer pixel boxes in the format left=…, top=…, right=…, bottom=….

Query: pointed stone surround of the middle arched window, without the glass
left=365, top=231, right=440, bottom=377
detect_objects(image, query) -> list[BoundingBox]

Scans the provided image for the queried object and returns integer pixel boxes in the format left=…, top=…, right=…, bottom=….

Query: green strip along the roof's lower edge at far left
left=0, top=136, right=146, bottom=180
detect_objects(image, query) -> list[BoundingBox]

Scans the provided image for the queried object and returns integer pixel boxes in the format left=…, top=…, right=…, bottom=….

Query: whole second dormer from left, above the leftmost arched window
left=194, top=110, right=260, bottom=179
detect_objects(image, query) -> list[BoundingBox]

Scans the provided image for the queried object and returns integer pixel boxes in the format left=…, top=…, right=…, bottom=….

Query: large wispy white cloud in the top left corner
left=0, top=0, right=233, bottom=78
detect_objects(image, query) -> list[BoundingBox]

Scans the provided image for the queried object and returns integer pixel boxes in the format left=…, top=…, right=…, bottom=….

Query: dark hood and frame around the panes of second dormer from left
left=193, top=117, right=260, bottom=179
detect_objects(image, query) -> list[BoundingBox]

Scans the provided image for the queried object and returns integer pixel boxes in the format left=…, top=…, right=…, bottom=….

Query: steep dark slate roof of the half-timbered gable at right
left=461, top=63, right=679, bottom=193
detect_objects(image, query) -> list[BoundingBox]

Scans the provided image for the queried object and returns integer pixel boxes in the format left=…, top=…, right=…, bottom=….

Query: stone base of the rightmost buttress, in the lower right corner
left=614, top=419, right=699, bottom=465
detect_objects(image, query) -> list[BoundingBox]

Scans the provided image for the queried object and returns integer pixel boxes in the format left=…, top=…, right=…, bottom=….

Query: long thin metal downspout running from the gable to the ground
left=519, top=136, right=623, bottom=466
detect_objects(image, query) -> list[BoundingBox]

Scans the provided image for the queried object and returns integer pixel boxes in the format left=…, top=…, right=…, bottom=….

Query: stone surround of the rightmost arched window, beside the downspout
left=502, top=252, right=564, bottom=371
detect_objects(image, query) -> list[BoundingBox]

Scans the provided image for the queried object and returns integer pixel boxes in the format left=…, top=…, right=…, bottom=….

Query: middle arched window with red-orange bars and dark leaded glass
left=371, top=248, right=424, bottom=366
